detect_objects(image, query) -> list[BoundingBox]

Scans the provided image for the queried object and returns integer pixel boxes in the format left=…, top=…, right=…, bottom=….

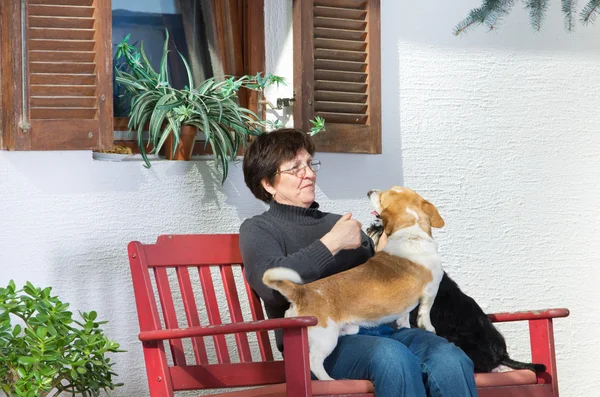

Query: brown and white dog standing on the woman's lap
left=263, top=186, right=444, bottom=380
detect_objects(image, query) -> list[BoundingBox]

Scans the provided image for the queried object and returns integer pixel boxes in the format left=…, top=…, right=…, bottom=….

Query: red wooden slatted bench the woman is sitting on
left=128, top=234, right=569, bottom=397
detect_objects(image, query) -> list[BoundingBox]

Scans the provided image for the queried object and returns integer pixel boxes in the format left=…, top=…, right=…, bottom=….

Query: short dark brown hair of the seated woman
left=243, top=128, right=315, bottom=202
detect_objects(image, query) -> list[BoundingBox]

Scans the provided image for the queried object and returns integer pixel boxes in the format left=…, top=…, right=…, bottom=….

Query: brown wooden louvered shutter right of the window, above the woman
left=293, top=0, right=381, bottom=153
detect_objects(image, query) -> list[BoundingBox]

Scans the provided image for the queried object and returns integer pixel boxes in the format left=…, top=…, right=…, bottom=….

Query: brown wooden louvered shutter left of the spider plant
left=3, top=0, right=113, bottom=150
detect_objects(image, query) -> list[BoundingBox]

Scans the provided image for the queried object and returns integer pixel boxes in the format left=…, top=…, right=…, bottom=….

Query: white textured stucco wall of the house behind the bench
left=0, top=0, right=600, bottom=397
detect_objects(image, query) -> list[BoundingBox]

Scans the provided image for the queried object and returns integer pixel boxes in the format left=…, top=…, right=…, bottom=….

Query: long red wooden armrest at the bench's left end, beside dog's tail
left=139, top=316, right=317, bottom=342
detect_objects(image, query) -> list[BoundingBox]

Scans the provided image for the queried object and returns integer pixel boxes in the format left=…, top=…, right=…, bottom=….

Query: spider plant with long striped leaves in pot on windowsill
left=115, top=31, right=283, bottom=181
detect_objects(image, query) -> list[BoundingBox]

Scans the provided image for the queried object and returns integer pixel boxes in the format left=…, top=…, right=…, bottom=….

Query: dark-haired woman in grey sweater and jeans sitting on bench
left=240, top=129, right=477, bottom=397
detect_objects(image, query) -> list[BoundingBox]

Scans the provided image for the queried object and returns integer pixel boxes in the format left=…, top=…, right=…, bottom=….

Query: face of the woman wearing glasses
left=262, top=149, right=317, bottom=208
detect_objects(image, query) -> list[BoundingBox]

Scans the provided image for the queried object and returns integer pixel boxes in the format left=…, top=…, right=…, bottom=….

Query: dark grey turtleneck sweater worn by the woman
left=240, top=201, right=375, bottom=351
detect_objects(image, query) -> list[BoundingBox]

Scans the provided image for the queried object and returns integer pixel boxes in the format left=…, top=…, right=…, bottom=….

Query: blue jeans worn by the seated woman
left=318, top=325, right=477, bottom=397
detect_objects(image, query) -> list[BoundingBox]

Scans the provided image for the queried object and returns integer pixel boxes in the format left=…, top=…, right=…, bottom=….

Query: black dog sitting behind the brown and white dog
left=367, top=220, right=546, bottom=372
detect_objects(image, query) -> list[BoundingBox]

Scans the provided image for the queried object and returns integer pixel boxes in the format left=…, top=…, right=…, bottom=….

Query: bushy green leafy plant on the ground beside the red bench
left=0, top=280, right=121, bottom=397
